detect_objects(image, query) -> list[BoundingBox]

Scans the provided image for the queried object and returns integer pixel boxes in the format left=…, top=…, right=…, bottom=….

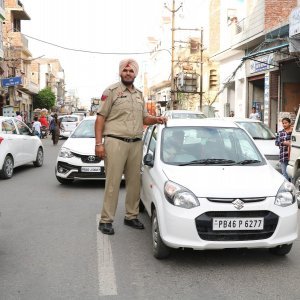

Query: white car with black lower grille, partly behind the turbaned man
left=55, top=116, right=105, bottom=184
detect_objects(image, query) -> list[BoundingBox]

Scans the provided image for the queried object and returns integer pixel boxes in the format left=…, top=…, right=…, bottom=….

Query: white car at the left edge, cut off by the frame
left=0, top=117, right=44, bottom=179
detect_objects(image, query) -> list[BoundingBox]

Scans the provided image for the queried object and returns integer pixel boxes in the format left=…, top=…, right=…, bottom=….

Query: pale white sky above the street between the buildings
left=21, top=0, right=207, bottom=105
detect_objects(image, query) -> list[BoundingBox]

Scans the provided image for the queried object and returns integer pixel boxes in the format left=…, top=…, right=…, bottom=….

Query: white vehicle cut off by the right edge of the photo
left=287, top=109, right=300, bottom=208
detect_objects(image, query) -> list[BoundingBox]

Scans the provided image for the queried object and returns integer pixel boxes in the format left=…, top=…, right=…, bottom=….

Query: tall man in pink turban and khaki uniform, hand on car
left=95, top=59, right=166, bottom=234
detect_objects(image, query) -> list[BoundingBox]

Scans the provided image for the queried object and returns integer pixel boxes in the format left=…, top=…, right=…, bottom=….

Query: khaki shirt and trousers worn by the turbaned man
left=98, top=82, right=148, bottom=223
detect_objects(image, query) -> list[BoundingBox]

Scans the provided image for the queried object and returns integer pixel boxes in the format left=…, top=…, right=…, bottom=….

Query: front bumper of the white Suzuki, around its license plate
left=157, top=197, right=298, bottom=250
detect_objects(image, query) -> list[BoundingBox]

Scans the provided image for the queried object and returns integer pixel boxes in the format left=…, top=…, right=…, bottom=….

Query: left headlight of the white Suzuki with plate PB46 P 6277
left=164, top=181, right=200, bottom=208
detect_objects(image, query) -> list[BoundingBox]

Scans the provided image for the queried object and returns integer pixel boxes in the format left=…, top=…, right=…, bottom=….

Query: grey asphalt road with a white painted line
left=0, top=138, right=300, bottom=300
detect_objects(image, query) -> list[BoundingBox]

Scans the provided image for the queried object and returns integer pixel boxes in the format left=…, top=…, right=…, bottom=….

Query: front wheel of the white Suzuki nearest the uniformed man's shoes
left=152, top=209, right=171, bottom=259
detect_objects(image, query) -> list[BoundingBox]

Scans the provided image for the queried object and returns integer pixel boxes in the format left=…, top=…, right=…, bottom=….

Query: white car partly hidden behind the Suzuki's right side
left=221, top=118, right=281, bottom=173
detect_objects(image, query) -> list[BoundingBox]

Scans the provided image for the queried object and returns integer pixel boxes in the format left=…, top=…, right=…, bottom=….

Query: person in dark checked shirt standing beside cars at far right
left=275, top=118, right=292, bottom=180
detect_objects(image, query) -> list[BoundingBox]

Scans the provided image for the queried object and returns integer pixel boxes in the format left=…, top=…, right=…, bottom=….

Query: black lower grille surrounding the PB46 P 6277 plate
left=195, top=211, right=278, bottom=241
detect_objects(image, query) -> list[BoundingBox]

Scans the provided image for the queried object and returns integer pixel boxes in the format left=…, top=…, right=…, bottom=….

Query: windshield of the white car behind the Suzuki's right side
left=236, top=121, right=275, bottom=140
